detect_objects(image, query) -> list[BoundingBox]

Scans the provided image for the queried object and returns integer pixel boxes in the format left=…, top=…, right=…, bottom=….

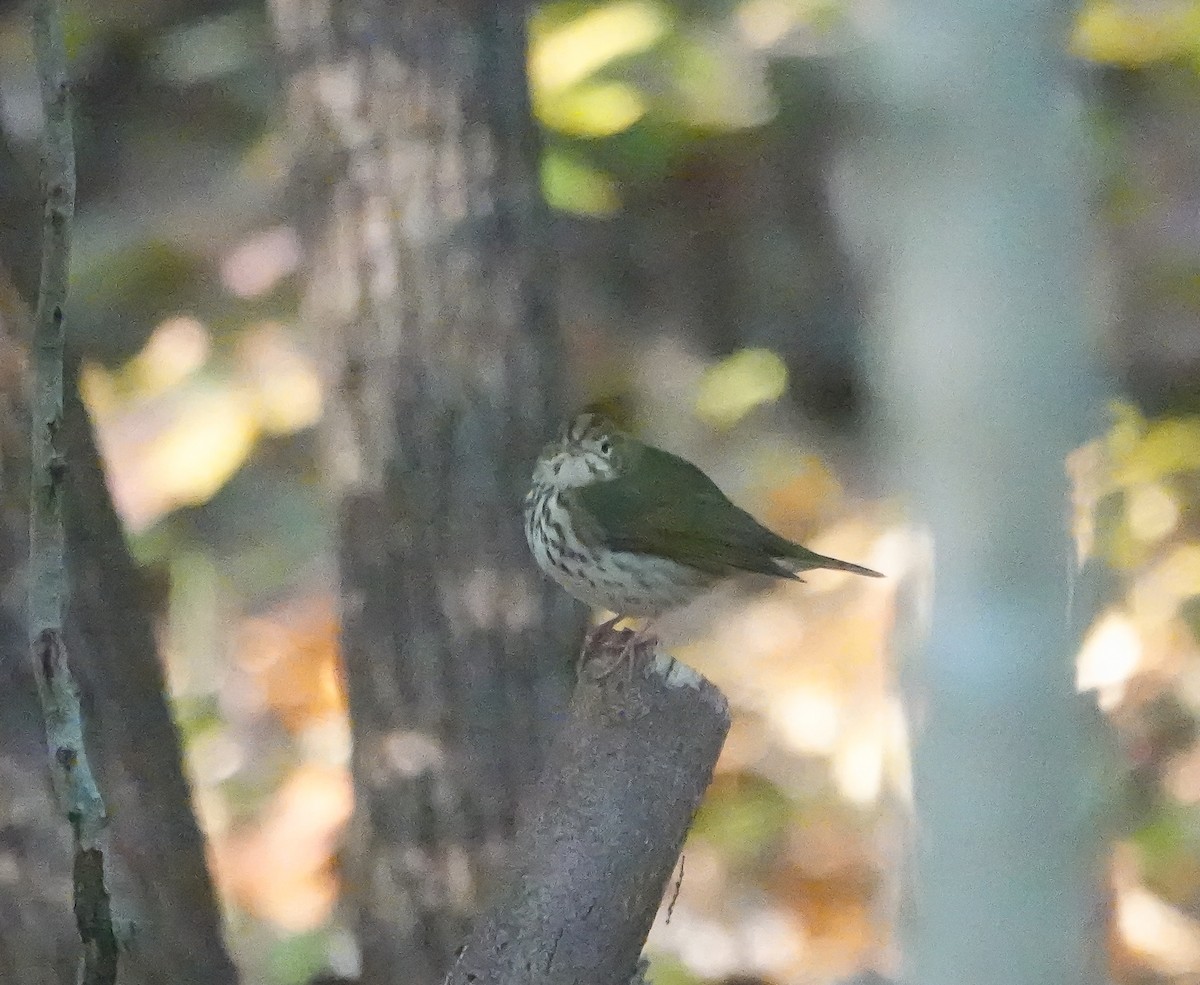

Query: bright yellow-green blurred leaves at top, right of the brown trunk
left=529, top=0, right=777, bottom=215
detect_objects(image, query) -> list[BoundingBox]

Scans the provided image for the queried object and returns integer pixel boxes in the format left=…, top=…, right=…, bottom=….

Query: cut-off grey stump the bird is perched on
left=446, top=638, right=730, bottom=985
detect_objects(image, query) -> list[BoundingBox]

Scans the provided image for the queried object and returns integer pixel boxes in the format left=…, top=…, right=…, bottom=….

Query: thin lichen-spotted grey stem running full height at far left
left=29, top=0, right=118, bottom=985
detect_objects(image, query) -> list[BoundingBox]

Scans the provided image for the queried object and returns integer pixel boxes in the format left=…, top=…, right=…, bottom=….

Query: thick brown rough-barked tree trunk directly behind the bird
left=276, top=0, right=577, bottom=984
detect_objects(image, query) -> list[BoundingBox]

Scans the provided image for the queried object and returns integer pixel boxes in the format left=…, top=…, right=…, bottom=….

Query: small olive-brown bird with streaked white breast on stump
left=524, top=410, right=882, bottom=677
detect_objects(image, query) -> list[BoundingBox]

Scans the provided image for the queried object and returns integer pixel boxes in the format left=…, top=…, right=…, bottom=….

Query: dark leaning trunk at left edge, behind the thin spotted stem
left=0, top=92, right=236, bottom=985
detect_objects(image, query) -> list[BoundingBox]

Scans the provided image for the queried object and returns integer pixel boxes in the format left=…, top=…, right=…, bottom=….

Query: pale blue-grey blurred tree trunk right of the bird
left=842, top=0, right=1105, bottom=985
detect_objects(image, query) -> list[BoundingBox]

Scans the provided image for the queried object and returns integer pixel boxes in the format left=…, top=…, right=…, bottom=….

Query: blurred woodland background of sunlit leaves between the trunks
left=0, top=0, right=1200, bottom=985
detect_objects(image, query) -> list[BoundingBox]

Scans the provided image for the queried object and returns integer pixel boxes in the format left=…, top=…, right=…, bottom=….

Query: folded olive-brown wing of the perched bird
left=571, top=448, right=796, bottom=578
